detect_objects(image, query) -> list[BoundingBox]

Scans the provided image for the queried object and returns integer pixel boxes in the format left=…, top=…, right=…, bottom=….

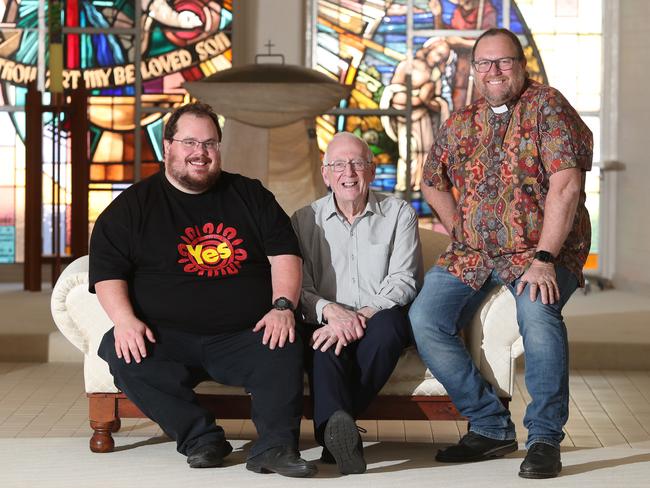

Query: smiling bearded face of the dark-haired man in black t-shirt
left=163, top=113, right=221, bottom=193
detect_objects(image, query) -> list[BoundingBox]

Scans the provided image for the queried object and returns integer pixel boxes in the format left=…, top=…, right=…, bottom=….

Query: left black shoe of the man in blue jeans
left=436, top=432, right=517, bottom=463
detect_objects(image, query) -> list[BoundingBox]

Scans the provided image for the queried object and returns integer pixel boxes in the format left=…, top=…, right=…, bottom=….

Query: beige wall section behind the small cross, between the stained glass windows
left=233, top=0, right=306, bottom=66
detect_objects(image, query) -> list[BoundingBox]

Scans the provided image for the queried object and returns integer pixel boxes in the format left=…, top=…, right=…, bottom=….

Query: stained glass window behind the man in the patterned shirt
left=312, top=0, right=602, bottom=266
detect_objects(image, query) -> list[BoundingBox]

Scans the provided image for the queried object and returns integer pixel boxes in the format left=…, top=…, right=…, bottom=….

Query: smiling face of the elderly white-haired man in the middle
left=321, top=132, right=375, bottom=208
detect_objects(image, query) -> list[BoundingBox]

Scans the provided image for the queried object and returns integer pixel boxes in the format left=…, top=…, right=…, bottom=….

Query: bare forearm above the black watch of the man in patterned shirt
left=537, top=169, right=582, bottom=256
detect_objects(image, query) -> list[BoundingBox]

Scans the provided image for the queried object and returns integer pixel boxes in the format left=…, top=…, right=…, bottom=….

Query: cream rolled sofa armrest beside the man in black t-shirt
left=50, top=256, right=118, bottom=393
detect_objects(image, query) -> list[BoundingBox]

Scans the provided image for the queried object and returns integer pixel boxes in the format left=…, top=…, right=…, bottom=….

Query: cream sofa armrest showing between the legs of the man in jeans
left=465, top=286, right=523, bottom=396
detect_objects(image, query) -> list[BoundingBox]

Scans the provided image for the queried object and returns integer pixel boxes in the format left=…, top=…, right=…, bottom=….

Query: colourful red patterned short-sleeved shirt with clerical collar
left=423, top=80, right=592, bottom=289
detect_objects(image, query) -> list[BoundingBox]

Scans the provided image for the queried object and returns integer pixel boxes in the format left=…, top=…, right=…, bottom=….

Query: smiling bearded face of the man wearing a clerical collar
left=474, top=34, right=526, bottom=107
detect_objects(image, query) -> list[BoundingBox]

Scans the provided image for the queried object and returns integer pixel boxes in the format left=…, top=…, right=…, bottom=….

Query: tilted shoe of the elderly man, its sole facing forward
left=325, top=410, right=366, bottom=474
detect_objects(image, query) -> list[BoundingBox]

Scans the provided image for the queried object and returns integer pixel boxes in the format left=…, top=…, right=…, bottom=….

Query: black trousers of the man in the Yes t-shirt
left=98, top=328, right=303, bottom=457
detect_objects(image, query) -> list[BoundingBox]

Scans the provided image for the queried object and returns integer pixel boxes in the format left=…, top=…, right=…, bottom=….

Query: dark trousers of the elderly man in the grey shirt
left=303, top=308, right=412, bottom=445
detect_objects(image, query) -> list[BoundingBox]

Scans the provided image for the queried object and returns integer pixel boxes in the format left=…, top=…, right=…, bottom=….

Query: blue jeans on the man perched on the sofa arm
left=409, top=266, right=578, bottom=448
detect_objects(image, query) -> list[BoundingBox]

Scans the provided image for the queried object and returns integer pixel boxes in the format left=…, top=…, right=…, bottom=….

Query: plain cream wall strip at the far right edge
left=614, top=0, right=650, bottom=289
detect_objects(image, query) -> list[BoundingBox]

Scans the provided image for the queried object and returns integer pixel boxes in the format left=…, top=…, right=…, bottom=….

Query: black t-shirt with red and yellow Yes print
left=89, top=171, right=300, bottom=334
